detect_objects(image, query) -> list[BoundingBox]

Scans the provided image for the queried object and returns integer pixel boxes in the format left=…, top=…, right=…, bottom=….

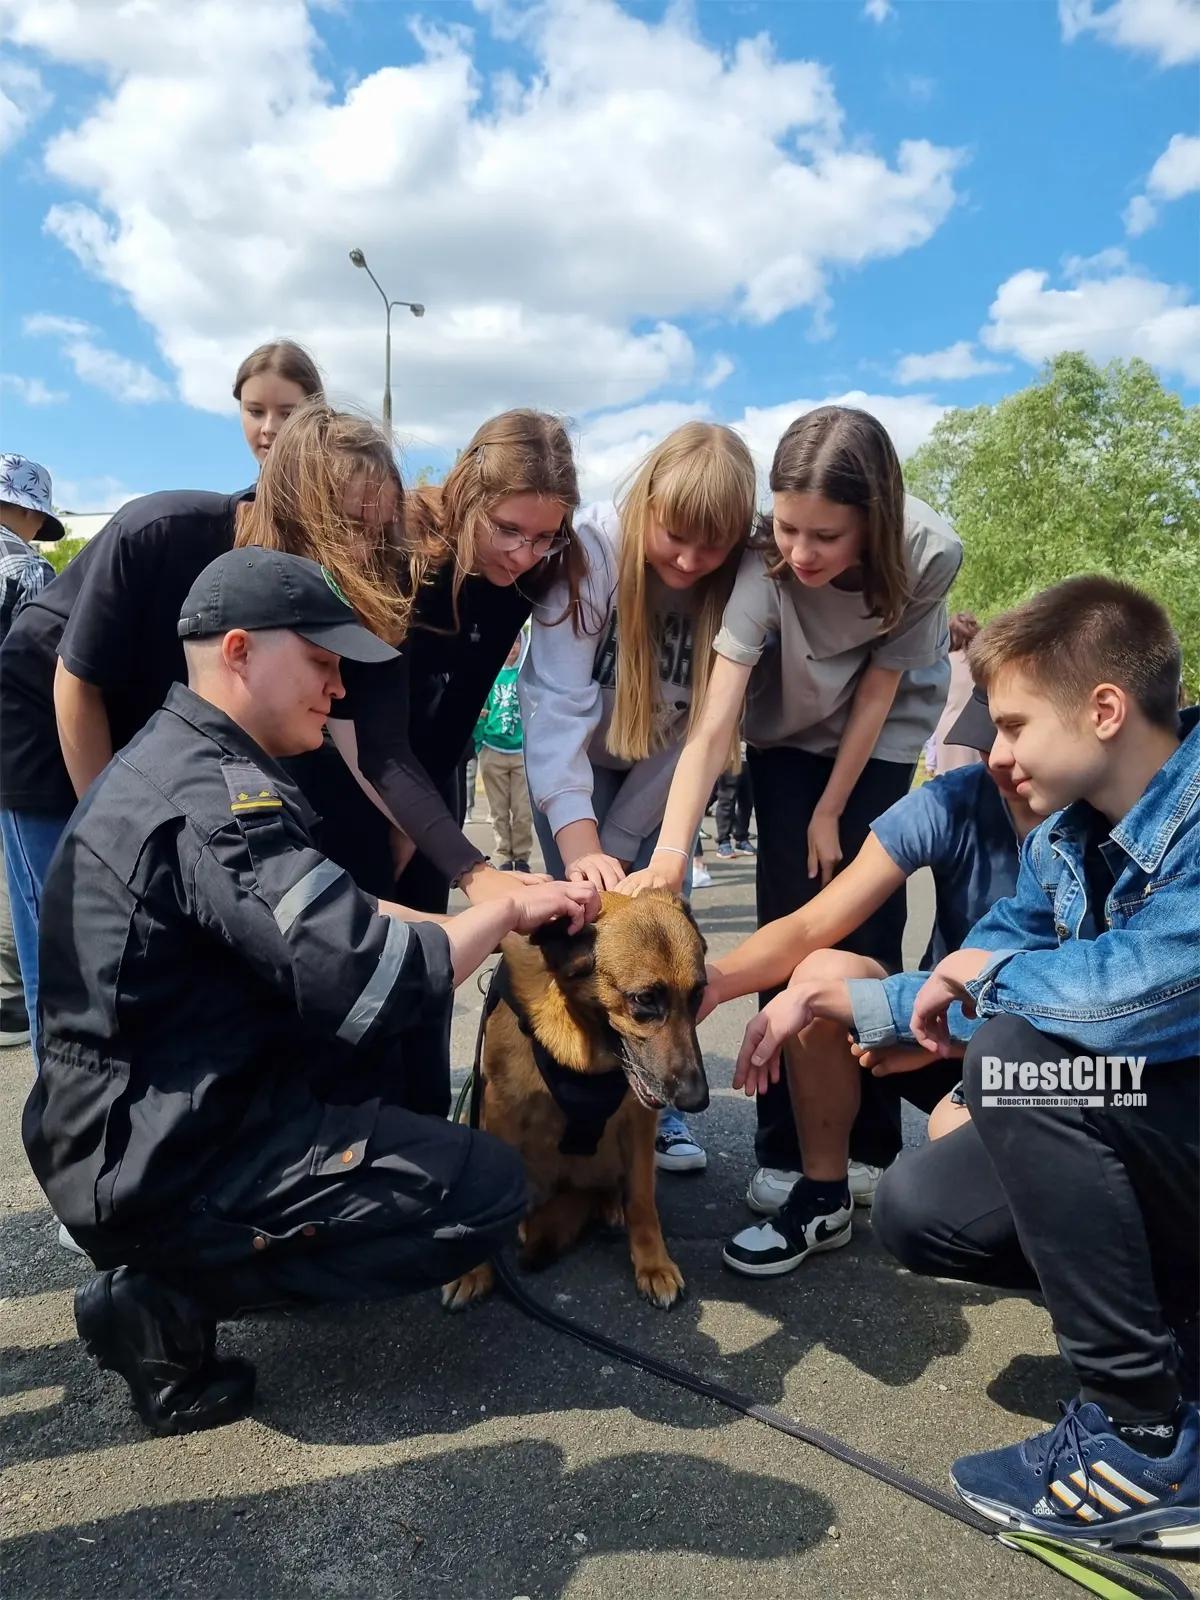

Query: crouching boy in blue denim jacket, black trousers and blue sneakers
left=734, top=576, right=1200, bottom=1549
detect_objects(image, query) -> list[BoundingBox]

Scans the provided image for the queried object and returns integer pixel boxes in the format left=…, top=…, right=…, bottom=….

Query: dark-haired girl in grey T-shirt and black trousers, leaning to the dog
left=621, top=406, right=963, bottom=1214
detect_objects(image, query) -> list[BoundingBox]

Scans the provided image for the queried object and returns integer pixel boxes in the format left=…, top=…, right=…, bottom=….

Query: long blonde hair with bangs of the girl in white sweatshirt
left=606, top=422, right=758, bottom=762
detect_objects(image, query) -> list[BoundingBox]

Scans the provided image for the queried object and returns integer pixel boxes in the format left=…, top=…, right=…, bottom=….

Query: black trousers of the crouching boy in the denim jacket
left=872, top=1016, right=1200, bottom=1418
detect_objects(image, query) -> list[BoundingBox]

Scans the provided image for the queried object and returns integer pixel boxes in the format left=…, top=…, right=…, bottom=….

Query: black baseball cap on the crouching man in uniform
left=176, top=544, right=398, bottom=662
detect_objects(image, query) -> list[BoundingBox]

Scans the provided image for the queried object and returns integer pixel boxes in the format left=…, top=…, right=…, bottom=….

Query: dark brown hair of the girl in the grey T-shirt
left=755, top=405, right=910, bottom=632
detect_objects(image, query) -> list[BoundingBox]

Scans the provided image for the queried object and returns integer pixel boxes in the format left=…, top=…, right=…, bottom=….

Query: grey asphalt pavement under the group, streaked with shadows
left=0, top=824, right=1184, bottom=1600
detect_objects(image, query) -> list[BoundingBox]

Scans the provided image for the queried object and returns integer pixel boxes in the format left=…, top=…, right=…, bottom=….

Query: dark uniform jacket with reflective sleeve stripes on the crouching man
left=22, top=685, right=456, bottom=1243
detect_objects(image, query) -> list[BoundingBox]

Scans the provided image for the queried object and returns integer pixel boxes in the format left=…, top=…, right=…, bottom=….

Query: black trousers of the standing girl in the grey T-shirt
left=746, top=746, right=915, bottom=1171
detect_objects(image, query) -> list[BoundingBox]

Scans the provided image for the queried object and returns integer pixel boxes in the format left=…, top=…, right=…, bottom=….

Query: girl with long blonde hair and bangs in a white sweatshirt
left=517, top=422, right=757, bottom=1171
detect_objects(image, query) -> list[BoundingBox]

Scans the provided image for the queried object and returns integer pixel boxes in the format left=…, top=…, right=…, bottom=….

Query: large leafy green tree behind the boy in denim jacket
left=904, top=352, right=1200, bottom=699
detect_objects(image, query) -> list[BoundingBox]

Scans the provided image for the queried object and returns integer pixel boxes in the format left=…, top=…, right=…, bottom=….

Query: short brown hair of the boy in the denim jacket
left=966, top=573, right=1182, bottom=731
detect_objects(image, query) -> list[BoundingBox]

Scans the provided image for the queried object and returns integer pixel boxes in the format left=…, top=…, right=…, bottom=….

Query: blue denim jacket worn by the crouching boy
left=848, top=707, right=1200, bottom=1062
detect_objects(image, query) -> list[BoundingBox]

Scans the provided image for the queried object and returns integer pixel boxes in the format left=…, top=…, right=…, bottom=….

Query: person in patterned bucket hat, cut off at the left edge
left=0, top=456, right=62, bottom=1050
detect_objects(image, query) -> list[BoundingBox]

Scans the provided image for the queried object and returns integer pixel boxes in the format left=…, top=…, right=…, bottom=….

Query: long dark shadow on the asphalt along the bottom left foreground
left=5, top=1440, right=835, bottom=1600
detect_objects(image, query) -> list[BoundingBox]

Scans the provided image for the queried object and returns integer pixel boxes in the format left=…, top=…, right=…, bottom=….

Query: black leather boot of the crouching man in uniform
left=75, top=1267, right=254, bottom=1434
